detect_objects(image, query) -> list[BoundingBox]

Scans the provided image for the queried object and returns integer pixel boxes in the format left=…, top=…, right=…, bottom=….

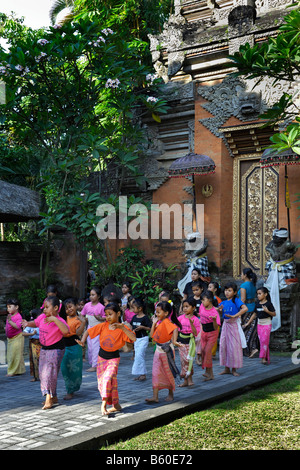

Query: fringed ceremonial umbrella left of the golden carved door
left=168, top=152, right=216, bottom=230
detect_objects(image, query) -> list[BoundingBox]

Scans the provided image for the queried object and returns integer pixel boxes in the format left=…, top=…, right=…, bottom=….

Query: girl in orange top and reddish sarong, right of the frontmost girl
left=146, top=301, right=181, bottom=403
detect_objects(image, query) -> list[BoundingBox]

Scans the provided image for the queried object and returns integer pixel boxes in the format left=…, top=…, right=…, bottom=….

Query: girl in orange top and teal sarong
left=61, top=298, right=85, bottom=400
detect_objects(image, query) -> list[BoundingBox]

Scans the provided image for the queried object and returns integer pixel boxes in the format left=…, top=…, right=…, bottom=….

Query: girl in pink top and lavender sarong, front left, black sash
left=22, top=297, right=69, bottom=410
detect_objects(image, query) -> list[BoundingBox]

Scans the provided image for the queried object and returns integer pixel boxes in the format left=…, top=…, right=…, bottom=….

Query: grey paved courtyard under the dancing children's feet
left=0, top=346, right=300, bottom=450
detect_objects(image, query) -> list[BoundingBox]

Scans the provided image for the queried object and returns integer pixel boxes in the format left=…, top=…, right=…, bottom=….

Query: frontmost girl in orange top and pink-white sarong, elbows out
left=77, top=302, right=136, bottom=415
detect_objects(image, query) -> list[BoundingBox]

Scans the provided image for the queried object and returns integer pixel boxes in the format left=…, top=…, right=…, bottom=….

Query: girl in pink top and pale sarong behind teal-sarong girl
left=81, top=286, right=105, bottom=372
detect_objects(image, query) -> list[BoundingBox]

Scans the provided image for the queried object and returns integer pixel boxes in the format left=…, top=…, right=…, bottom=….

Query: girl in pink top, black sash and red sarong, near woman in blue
left=199, top=291, right=221, bottom=381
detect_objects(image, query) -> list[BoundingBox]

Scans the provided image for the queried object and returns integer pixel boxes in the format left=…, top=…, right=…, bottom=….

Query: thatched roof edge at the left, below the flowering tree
left=0, top=181, right=40, bottom=222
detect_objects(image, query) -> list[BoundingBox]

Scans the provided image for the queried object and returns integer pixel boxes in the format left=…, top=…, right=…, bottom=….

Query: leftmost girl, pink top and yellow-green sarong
left=5, top=299, right=26, bottom=377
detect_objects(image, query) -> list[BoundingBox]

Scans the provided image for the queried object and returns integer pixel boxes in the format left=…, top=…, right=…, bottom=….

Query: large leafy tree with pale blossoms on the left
left=0, top=11, right=166, bottom=253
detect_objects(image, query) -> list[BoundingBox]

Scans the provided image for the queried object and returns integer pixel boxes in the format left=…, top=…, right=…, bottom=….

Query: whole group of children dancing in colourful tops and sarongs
left=6, top=279, right=276, bottom=415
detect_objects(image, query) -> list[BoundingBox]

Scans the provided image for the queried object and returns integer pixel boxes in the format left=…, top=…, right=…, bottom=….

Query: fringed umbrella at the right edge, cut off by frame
left=260, top=148, right=300, bottom=239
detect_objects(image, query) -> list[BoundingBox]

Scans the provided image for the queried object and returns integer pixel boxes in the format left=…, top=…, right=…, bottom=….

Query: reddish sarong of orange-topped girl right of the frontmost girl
left=152, top=344, right=175, bottom=391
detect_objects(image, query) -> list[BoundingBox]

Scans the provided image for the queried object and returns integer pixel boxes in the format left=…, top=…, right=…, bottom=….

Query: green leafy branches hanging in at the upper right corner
left=229, top=1, right=300, bottom=155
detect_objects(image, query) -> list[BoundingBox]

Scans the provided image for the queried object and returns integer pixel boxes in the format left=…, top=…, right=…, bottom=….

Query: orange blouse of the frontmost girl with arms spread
left=87, top=321, right=133, bottom=352
